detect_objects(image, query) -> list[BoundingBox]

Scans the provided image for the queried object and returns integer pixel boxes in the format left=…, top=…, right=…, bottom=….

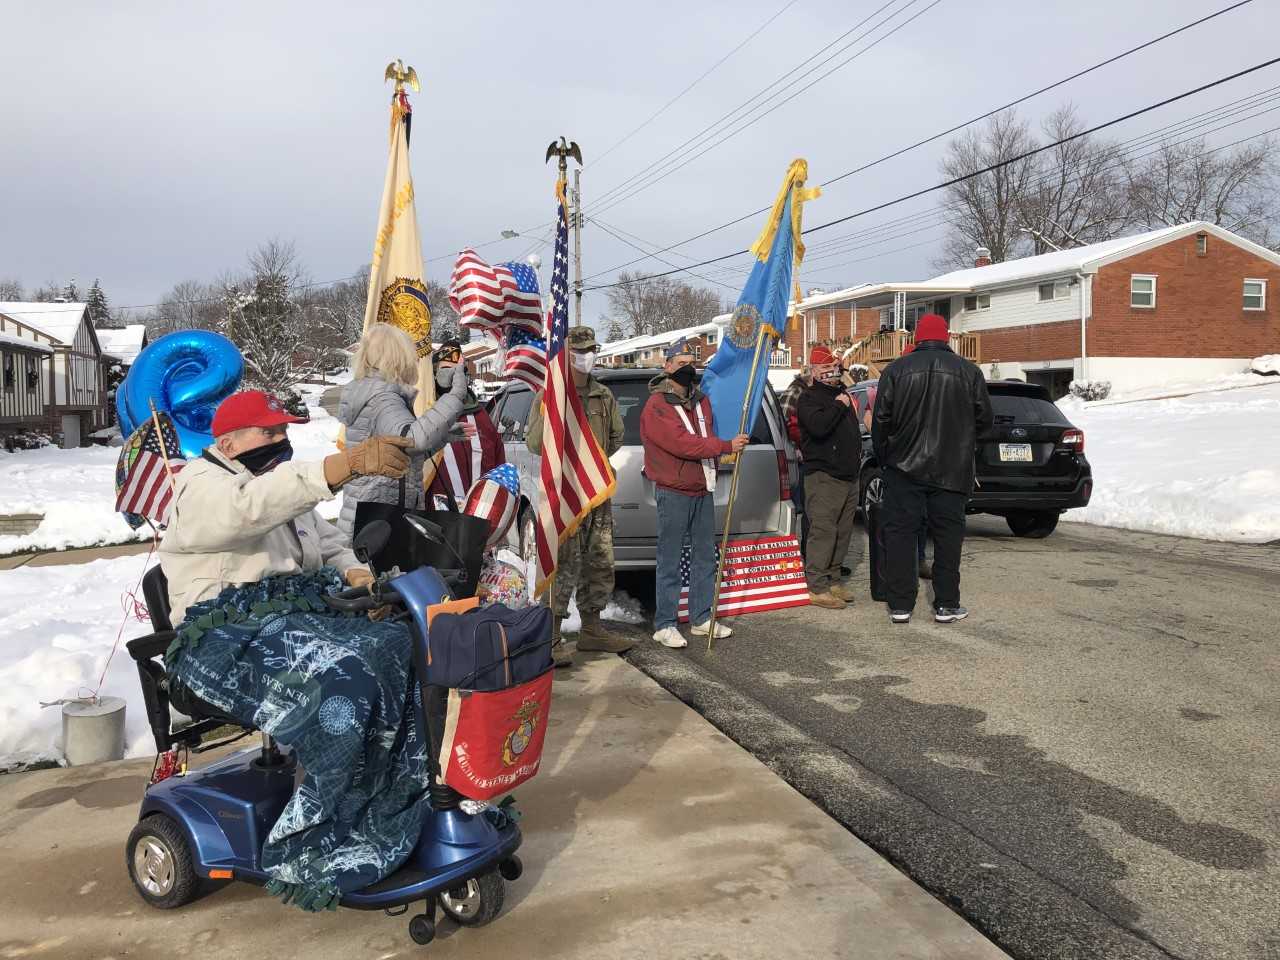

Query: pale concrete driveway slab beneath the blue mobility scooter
left=0, top=657, right=1005, bottom=960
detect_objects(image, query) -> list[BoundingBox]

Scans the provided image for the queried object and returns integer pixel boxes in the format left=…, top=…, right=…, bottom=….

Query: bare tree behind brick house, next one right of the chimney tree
left=1018, top=104, right=1130, bottom=253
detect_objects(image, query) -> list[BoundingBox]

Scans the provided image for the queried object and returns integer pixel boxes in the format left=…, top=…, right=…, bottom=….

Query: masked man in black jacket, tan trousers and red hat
left=796, top=347, right=863, bottom=611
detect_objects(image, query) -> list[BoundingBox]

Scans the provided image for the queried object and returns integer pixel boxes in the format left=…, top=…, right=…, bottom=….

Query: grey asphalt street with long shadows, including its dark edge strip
left=623, top=517, right=1280, bottom=960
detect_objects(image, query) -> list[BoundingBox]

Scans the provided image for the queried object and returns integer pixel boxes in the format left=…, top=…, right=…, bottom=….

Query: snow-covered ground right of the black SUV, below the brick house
left=1059, top=374, right=1280, bottom=543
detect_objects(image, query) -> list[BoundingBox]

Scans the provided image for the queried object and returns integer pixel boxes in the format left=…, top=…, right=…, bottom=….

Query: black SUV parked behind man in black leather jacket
left=852, top=380, right=1093, bottom=538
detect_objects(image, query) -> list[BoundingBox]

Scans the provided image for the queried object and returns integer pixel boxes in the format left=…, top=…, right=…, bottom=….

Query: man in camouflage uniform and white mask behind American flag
left=525, top=326, right=634, bottom=667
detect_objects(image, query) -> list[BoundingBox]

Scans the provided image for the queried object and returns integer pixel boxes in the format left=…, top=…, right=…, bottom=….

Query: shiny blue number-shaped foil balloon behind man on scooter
left=115, top=330, right=244, bottom=460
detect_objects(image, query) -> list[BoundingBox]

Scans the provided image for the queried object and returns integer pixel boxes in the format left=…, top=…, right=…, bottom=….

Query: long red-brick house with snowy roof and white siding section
left=800, top=221, right=1280, bottom=396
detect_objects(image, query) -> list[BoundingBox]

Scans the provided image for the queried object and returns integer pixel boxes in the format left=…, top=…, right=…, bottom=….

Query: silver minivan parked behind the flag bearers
left=489, top=369, right=797, bottom=570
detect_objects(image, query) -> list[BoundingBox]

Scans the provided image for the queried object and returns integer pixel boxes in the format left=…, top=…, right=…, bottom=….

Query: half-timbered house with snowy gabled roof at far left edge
left=0, top=301, right=111, bottom=448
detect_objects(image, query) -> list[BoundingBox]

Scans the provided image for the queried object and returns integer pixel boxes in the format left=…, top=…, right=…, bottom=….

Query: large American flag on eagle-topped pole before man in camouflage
left=534, top=179, right=617, bottom=593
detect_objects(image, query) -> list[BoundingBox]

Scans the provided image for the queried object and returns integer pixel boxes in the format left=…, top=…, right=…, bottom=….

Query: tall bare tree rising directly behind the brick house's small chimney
left=940, top=110, right=1036, bottom=269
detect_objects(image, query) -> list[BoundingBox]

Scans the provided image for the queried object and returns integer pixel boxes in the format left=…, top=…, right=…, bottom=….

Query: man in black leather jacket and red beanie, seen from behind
left=872, top=314, right=992, bottom=623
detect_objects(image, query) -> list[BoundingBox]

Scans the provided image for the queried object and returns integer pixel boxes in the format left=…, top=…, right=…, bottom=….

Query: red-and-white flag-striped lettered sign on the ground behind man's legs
left=676, top=536, right=809, bottom=623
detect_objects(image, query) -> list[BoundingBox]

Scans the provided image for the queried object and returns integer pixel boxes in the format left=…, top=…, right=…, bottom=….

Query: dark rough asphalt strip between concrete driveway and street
left=625, top=637, right=1180, bottom=960
